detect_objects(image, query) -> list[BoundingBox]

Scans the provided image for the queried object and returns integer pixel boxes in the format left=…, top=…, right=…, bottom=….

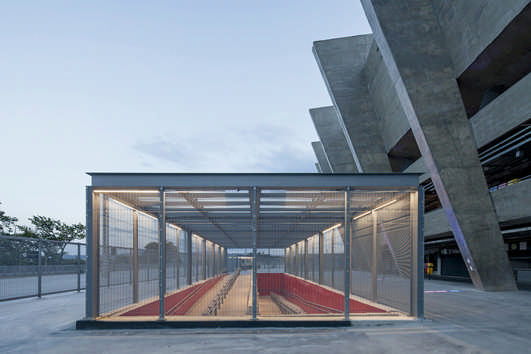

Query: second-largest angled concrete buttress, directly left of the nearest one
left=313, top=34, right=391, bottom=172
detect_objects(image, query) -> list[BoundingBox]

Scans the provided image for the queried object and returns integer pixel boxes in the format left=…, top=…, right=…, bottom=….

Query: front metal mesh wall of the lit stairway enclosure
left=87, top=188, right=416, bottom=316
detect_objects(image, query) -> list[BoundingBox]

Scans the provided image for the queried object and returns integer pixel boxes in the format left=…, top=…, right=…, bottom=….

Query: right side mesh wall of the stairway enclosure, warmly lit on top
left=351, top=192, right=415, bottom=312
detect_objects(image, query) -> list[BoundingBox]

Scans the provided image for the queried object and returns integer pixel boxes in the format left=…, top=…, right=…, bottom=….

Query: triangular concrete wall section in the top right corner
left=433, top=0, right=529, bottom=77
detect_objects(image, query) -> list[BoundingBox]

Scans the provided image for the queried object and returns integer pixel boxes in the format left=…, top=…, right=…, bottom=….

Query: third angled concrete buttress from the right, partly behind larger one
left=310, top=106, right=358, bottom=173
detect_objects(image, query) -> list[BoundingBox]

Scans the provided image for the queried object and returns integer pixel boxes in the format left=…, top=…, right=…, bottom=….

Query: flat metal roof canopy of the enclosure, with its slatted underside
left=89, top=173, right=419, bottom=248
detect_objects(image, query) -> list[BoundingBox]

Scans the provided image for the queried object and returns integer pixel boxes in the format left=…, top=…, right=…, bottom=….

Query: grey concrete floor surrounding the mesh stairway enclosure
left=0, top=280, right=531, bottom=353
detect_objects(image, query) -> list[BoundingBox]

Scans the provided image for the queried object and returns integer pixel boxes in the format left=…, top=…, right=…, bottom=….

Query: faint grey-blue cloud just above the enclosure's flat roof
left=133, top=124, right=314, bottom=172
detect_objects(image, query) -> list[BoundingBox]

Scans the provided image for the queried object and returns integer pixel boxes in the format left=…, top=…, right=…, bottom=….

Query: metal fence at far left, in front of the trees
left=0, top=235, right=86, bottom=301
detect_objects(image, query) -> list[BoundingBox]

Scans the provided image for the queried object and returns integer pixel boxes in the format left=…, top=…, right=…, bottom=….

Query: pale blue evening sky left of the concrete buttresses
left=0, top=0, right=371, bottom=225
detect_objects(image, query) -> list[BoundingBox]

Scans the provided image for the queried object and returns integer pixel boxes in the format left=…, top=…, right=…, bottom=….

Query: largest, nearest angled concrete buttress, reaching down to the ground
left=361, top=0, right=516, bottom=290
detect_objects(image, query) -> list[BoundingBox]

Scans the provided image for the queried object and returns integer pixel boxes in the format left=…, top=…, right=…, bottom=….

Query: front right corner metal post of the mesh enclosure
left=410, top=186, right=424, bottom=318
